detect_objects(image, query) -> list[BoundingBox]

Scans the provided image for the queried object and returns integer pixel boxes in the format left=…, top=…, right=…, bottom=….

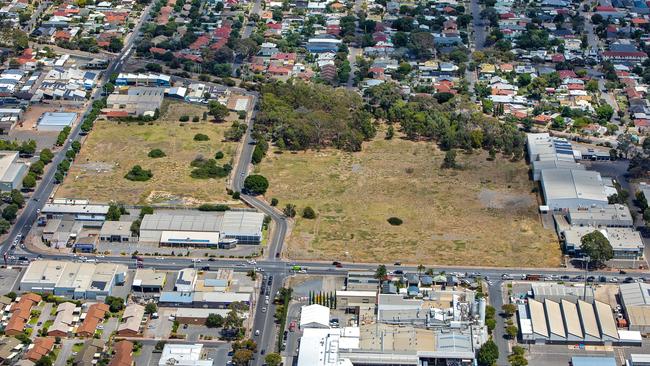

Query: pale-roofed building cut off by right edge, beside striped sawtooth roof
left=619, top=283, right=650, bottom=335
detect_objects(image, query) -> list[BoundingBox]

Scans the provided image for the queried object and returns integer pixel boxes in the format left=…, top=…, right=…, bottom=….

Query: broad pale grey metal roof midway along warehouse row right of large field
left=541, top=169, right=609, bottom=210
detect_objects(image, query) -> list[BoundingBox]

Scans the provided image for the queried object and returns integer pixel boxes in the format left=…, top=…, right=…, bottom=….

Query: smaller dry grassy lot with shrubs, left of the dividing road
left=56, top=103, right=236, bottom=204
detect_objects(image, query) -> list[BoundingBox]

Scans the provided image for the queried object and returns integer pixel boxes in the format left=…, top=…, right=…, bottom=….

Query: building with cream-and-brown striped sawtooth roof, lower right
left=517, top=299, right=641, bottom=346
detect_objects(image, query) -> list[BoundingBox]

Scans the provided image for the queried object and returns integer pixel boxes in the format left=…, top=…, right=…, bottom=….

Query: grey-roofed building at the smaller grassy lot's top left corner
left=102, top=87, right=165, bottom=118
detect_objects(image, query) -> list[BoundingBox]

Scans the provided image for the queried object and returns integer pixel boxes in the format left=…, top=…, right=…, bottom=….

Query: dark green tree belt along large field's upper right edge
left=366, top=83, right=525, bottom=160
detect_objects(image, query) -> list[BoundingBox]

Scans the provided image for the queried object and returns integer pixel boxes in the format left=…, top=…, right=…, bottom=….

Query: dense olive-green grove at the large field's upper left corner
left=255, top=81, right=376, bottom=151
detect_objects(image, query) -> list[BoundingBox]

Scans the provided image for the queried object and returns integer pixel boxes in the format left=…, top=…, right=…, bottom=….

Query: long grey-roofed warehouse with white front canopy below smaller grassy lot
left=140, top=211, right=264, bottom=248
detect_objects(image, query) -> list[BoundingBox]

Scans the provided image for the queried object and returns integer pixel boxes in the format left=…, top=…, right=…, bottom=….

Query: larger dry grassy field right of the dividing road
left=260, top=139, right=560, bottom=267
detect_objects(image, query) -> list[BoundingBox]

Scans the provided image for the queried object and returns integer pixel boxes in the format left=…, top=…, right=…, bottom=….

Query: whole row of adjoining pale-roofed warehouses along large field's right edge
left=527, top=133, right=645, bottom=262
